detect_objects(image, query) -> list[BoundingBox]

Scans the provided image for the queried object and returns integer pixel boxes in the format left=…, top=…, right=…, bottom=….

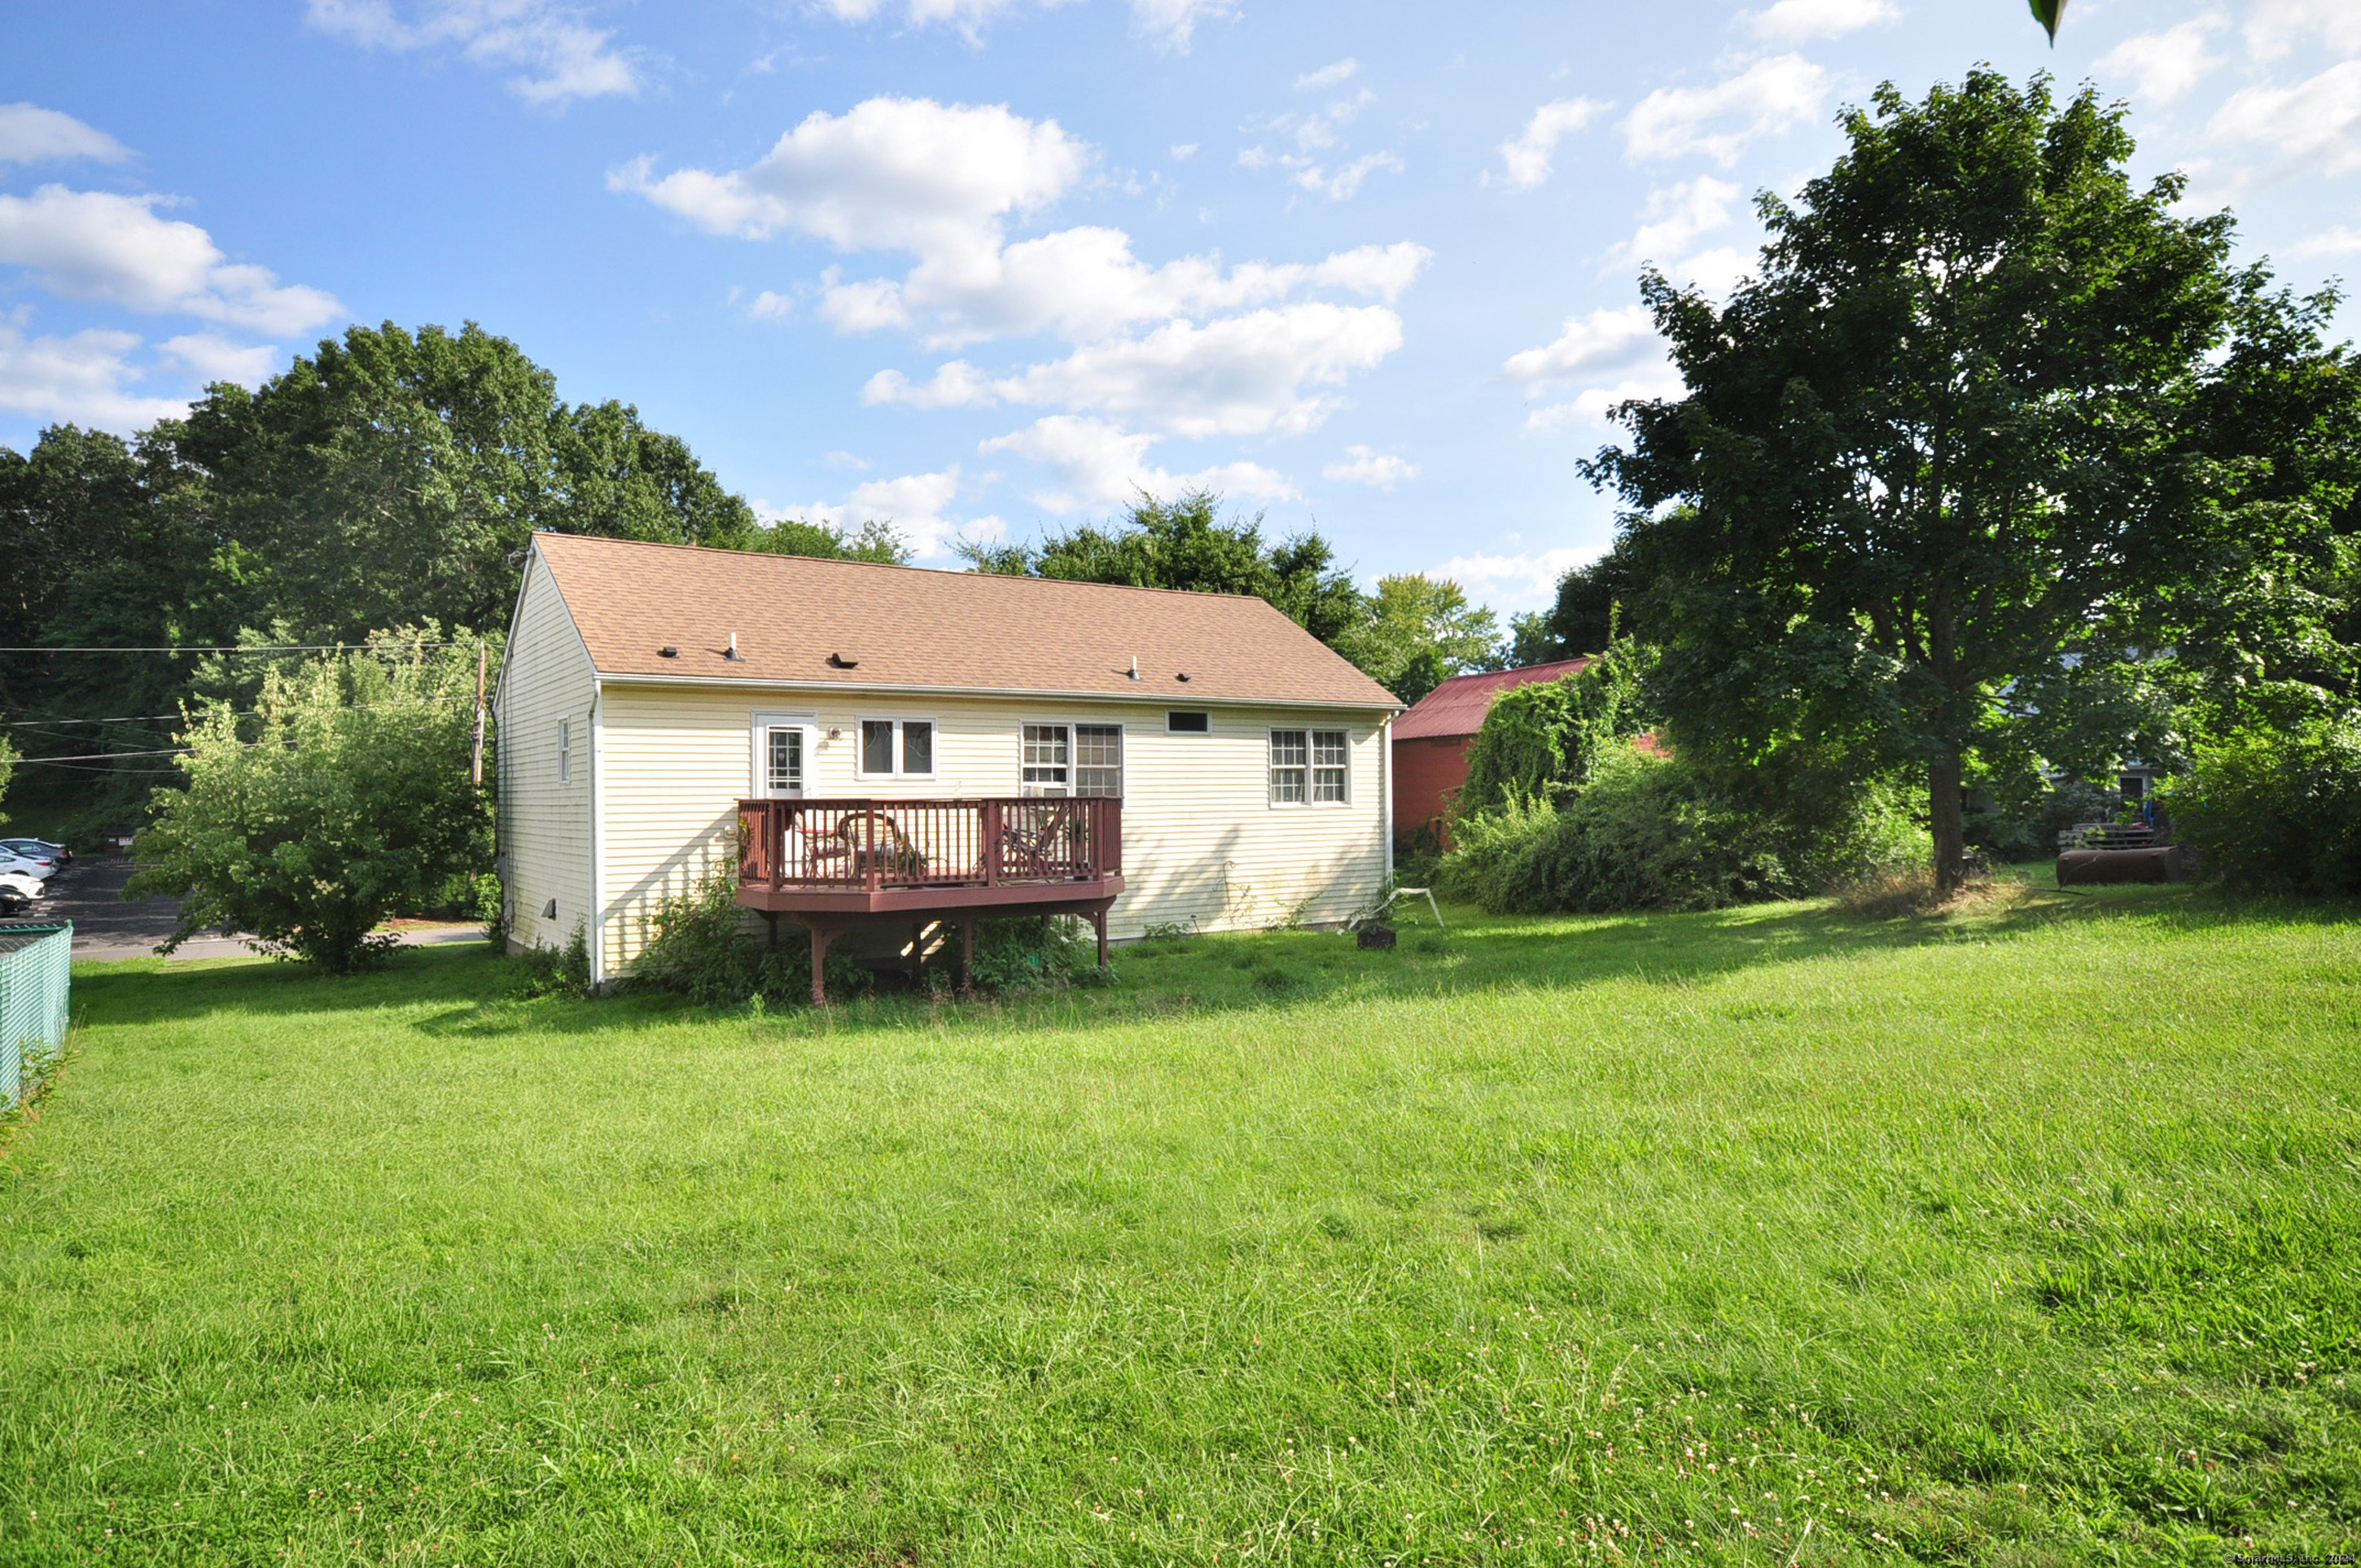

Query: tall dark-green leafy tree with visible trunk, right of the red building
left=1589, top=71, right=2354, bottom=888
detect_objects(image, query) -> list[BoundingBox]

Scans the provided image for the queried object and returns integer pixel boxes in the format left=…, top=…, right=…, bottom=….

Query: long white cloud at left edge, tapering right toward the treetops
left=0, top=184, right=344, bottom=333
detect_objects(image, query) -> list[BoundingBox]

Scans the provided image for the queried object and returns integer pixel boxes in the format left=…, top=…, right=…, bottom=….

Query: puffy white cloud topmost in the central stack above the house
left=607, top=97, right=1089, bottom=247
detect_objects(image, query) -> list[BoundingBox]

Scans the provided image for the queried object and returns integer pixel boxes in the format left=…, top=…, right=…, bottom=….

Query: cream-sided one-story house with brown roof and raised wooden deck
left=496, top=534, right=1400, bottom=983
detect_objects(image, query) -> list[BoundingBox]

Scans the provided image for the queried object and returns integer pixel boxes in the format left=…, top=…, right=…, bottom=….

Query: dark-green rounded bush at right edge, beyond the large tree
left=2162, top=718, right=2361, bottom=897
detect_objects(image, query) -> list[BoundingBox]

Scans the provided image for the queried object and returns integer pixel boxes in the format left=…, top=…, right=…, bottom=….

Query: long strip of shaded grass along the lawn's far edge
left=76, top=888, right=2356, bottom=1036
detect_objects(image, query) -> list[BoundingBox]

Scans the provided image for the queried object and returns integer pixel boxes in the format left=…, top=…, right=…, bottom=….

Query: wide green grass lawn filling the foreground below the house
left=0, top=888, right=2361, bottom=1568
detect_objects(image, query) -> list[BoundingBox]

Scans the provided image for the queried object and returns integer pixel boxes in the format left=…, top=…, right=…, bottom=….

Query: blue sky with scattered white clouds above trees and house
left=0, top=0, right=2361, bottom=609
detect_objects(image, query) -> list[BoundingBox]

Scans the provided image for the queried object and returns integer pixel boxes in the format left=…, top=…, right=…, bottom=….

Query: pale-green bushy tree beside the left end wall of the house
left=130, top=626, right=496, bottom=973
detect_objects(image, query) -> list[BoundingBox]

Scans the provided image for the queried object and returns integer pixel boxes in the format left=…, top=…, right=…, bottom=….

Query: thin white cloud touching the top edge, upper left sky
left=307, top=0, right=642, bottom=104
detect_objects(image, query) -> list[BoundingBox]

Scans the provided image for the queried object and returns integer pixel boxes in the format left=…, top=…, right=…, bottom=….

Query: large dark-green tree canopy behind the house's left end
left=0, top=323, right=902, bottom=831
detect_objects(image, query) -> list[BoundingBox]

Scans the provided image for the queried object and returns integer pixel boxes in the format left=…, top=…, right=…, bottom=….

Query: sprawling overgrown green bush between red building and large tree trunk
left=1440, top=747, right=1926, bottom=914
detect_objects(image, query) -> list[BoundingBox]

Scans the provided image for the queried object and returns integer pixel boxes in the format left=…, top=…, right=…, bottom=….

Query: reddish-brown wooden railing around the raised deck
left=739, top=796, right=1124, bottom=891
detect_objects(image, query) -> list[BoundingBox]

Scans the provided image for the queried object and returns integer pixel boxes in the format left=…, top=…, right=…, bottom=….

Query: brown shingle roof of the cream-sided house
left=533, top=534, right=1400, bottom=708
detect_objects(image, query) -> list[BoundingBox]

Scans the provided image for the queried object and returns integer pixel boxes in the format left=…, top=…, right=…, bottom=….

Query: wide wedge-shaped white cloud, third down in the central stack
left=862, top=302, right=1403, bottom=437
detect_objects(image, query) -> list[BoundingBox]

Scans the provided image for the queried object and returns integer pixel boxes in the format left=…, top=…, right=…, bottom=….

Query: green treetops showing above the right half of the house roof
left=958, top=491, right=1362, bottom=647
